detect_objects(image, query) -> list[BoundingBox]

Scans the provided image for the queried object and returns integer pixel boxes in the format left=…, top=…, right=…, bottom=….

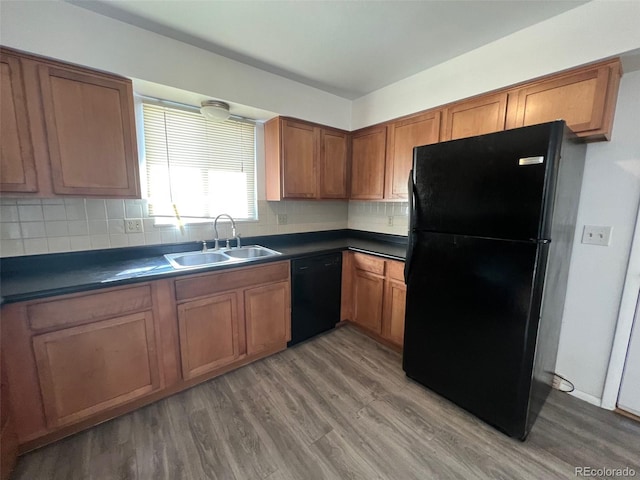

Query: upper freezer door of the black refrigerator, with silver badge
left=413, top=122, right=564, bottom=240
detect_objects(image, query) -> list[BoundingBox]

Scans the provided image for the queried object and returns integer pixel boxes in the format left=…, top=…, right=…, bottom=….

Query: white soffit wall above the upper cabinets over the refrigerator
left=351, top=0, right=640, bottom=130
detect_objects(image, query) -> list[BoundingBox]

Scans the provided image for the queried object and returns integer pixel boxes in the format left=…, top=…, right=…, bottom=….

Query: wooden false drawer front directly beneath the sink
left=176, top=262, right=289, bottom=301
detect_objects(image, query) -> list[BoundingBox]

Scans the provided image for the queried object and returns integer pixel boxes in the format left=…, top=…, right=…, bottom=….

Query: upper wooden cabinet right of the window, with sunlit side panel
left=265, top=117, right=348, bottom=200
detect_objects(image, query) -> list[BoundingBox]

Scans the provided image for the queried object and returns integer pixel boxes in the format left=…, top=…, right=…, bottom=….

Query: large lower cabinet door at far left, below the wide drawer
left=33, top=312, right=160, bottom=428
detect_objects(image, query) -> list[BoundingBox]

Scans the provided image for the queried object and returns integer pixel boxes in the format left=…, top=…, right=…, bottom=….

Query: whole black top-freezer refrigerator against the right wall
left=403, top=121, right=585, bottom=440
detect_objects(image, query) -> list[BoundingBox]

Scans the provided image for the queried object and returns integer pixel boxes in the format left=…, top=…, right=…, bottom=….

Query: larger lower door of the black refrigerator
left=403, top=232, right=544, bottom=439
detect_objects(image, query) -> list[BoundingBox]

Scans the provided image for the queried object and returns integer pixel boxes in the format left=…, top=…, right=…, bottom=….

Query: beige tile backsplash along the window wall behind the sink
left=0, top=198, right=349, bottom=257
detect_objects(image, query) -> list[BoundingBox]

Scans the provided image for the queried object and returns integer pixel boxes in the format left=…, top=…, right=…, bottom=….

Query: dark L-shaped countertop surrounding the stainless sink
left=0, top=230, right=407, bottom=303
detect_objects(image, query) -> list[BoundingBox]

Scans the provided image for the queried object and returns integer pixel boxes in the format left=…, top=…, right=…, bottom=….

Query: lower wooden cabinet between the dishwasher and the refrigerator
left=341, top=252, right=407, bottom=347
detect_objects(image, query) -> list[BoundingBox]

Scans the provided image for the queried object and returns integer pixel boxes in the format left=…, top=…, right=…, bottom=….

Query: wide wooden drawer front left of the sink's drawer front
left=27, top=285, right=151, bottom=330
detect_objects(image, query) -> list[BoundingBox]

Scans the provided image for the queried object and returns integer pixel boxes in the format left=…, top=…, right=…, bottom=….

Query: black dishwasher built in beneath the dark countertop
left=287, top=252, right=342, bottom=346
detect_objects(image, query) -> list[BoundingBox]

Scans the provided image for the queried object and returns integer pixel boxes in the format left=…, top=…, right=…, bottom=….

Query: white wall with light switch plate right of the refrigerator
left=557, top=71, right=640, bottom=403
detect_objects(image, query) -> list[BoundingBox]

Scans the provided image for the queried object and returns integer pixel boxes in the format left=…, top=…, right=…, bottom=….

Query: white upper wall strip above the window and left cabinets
left=0, top=0, right=351, bottom=129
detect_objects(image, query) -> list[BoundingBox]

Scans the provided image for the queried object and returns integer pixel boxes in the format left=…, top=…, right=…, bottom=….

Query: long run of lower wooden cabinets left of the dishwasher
left=1, top=261, right=291, bottom=452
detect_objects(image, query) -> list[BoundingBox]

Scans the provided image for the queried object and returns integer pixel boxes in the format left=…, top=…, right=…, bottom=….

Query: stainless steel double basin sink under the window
left=164, top=245, right=282, bottom=269
